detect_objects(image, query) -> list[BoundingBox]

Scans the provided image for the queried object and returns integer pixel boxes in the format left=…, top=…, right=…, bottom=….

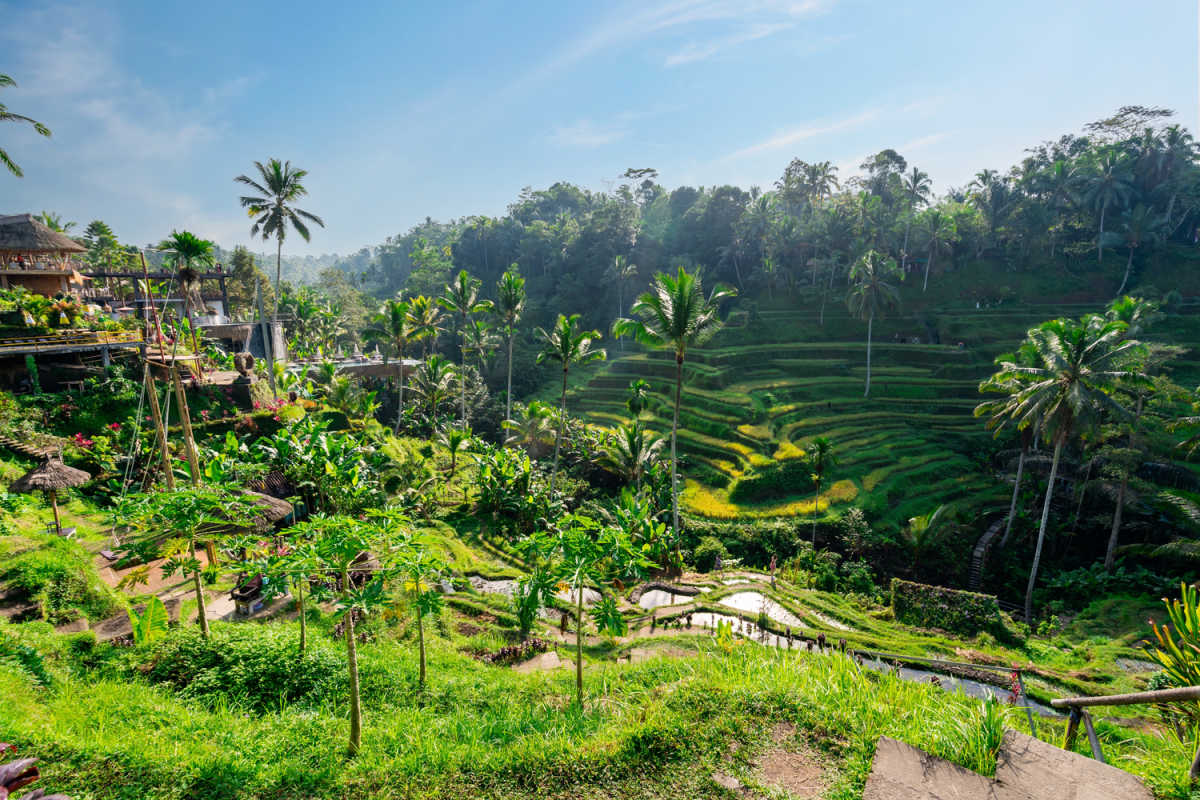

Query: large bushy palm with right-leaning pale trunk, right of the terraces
left=982, top=315, right=1141, bottom=622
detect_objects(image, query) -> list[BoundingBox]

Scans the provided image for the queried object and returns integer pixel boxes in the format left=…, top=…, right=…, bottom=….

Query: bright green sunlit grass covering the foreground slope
left=0, top=624, right=1190, bottom=800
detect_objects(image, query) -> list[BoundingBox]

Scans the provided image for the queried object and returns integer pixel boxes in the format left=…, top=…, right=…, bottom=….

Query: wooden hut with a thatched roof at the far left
left=0, top=213, right=89, bottom=297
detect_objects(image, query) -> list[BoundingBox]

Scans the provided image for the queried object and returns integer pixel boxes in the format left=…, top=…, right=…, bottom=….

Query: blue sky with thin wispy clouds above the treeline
left=0, top=0, right=1198, bottom=254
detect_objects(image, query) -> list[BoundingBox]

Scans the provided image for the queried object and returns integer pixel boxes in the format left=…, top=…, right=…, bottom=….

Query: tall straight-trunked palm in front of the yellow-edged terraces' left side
left=612, top=266, right=737, bottom=546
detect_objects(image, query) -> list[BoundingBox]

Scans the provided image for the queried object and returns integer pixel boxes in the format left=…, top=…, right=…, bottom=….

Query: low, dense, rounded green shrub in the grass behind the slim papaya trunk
left=142, top=625, right=347, bottom=711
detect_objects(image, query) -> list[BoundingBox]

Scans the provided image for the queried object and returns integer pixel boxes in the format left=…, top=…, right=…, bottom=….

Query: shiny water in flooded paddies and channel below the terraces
left=470, top=576, right=1062, bottom=722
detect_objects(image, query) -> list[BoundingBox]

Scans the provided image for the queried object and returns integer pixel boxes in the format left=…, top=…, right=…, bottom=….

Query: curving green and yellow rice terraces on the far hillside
left=570, top=305, right=1200, bottom=532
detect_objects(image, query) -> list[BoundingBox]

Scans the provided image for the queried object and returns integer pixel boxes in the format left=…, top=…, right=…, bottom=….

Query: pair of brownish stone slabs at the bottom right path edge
left=863, top=730, right=1153, bottom=800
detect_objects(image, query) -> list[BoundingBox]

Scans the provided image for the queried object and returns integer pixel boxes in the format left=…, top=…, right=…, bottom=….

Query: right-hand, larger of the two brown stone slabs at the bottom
left=996, top=730, right=1154, bottom=800
